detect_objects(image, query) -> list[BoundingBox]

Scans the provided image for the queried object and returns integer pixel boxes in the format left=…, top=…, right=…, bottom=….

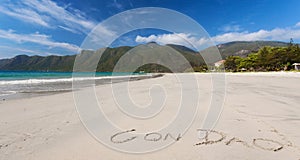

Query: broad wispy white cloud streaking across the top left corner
left=0, top=0, right=96, bottom=33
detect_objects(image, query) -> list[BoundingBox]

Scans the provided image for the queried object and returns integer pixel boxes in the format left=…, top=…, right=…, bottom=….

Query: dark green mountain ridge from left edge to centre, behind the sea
left=0, top=42, right=204, bottom=72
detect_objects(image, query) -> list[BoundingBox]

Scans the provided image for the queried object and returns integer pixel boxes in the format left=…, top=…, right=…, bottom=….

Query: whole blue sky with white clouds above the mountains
left=0, top=0, right=300, bottom=59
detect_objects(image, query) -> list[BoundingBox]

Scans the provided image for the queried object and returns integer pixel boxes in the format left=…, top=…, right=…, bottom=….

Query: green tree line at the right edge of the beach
left=224, top=40, right=300, bottom=72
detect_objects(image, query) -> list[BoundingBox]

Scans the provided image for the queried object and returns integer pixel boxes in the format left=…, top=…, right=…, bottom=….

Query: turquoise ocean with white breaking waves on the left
left=0, top=71, right=148, bottom=100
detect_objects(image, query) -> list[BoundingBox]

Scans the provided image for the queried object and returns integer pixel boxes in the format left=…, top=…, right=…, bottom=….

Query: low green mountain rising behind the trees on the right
left=217, top=41, right=289, bottom=59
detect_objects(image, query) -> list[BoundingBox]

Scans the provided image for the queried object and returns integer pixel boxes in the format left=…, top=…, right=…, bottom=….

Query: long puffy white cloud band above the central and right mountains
left=135, top=25, right=300, bottom=48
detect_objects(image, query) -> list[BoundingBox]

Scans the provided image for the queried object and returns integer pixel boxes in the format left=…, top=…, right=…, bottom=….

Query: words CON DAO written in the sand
left=110, top=129, right=285, bottom=152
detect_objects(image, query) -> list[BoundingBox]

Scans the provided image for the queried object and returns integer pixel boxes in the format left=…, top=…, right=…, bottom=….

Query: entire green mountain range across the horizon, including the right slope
left=0, top=41, right=289, bottom=72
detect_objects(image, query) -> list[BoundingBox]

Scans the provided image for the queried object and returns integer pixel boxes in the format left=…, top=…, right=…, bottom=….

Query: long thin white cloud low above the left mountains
left=0, top=29, right=80, bottom=53
